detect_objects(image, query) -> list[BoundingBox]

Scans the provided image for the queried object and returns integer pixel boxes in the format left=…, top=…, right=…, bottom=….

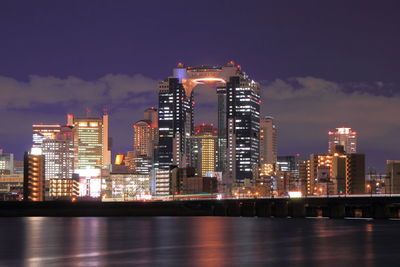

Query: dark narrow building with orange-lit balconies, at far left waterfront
left=24, top=152, right=45, bottom=201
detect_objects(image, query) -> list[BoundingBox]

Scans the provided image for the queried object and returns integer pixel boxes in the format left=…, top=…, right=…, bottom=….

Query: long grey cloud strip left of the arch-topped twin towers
left=0, top=74, right=157, bottom=109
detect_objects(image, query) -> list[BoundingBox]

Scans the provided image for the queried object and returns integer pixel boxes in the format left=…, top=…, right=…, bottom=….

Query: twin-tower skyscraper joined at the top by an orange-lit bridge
left=158, top=62, right=260, bottom=192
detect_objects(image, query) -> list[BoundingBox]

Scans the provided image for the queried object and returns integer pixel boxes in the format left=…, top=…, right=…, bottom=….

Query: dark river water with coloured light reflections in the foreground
left=0, top=217, right=400, bottom=266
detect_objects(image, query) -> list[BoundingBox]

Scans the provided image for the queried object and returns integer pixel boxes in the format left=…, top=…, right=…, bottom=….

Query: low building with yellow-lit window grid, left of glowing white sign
left=49, top=177, right=79, bottom=199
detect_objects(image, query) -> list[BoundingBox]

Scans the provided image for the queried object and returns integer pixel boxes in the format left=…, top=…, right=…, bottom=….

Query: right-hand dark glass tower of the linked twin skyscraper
left=226, top=74, right=261, bottom=185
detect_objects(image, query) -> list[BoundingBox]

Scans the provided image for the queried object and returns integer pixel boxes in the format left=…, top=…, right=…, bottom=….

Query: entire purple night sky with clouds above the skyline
left=0, top=0, right=400, bottom=170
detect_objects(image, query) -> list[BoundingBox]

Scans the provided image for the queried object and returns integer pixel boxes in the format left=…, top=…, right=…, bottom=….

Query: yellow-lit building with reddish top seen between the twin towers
left=188, top=123, right=218, bottom=177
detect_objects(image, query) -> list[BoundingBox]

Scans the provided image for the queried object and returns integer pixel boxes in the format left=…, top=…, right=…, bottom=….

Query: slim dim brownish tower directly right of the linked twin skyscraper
left=260, top=116, right=278, bottom=164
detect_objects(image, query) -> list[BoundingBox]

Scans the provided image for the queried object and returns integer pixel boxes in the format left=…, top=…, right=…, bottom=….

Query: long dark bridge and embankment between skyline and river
left=0, top=195, right=400, bottom=219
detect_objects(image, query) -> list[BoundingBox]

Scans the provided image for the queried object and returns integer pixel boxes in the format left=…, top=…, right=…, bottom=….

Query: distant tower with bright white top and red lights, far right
left=328, top=127, right=357, bottom=154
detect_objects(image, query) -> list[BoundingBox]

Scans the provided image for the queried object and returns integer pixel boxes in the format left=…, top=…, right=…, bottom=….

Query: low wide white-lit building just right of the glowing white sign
left=103, top=173, right=150, bottom=201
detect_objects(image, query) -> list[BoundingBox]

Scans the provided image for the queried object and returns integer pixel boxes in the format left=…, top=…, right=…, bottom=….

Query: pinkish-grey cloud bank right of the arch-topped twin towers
left=262, top=77, right=400, bottom=170
